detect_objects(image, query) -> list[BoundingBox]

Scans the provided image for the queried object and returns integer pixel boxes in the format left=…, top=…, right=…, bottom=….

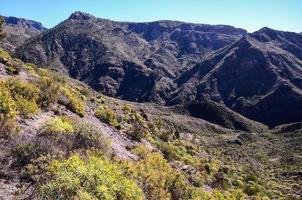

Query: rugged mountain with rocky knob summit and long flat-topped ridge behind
left=16, top=12, right=246, bottom=103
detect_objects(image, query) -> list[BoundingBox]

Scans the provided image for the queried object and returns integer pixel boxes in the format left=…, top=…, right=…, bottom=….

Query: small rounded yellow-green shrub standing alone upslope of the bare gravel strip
left=95, top=105, right=118, bottom=126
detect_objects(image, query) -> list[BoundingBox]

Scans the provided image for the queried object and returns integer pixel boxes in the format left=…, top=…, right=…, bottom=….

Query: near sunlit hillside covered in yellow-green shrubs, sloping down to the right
left=0, top=47, right=302, bottom=199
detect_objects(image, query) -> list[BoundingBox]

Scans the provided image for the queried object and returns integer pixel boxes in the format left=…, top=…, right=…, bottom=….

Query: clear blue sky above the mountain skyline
left=0, top=0, right=302, bottom=32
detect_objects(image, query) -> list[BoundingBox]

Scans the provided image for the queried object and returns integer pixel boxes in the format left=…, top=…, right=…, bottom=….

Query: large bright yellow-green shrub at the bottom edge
left=39, top=155, right=143, bottom=200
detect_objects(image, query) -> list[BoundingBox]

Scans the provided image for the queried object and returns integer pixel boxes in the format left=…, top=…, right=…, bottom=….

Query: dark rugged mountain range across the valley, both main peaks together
left=1, top=12, right=302, bottom=127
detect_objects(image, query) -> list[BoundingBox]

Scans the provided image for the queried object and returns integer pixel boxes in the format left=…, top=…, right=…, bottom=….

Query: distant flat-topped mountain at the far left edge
left=0, top=16, right=46, bottom=52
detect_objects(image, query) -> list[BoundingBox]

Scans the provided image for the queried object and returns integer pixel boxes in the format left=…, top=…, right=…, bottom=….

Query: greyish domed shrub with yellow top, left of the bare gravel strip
left=38, top=117, right=111, bottom=155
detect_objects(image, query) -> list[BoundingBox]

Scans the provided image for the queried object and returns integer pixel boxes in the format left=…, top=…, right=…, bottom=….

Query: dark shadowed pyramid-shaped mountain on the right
left=171, top=28, right=302, bottom=126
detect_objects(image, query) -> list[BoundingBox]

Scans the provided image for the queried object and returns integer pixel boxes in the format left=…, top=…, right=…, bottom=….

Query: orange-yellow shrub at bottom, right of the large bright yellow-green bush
left=129, top=152, right=195, bottom=200
